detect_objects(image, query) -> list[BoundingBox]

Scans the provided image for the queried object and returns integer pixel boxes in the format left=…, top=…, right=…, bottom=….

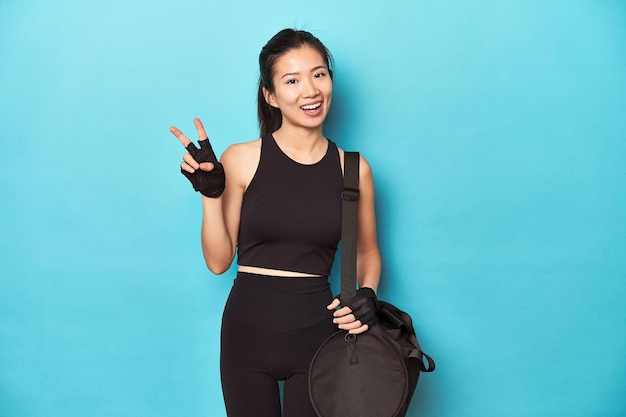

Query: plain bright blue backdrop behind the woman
left=0, top=0, right=626, bottom=417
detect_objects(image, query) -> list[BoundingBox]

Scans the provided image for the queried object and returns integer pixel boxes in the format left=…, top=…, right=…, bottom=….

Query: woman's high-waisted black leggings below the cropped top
left=220, top=272, right=337, bottom=417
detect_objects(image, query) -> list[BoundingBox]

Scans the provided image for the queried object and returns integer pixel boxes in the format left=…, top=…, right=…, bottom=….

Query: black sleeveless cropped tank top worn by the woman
left=237, top=134, right=343, bottom=276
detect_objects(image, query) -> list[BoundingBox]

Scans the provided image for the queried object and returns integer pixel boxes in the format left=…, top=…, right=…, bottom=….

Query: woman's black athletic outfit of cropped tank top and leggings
left=221, top=135, right=343, bottom=417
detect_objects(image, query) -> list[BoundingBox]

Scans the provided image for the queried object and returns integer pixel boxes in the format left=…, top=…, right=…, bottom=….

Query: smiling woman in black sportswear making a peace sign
left=170, top=29, right=381, bottom=417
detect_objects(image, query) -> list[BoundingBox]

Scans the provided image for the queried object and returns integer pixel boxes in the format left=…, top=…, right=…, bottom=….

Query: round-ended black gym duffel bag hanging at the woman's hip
left=309, top=301, right=435, bottom=417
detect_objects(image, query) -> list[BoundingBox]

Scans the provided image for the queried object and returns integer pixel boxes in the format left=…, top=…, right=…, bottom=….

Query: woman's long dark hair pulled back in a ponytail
left=257, top=29, right=333, bottom=136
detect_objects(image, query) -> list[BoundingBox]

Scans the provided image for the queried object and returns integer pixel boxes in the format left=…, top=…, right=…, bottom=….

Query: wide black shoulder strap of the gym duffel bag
left=341, top=152, right=360, bottom=302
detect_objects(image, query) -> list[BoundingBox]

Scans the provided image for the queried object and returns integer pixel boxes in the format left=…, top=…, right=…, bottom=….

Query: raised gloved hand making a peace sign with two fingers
left=170, top=118, right=226, bottom=198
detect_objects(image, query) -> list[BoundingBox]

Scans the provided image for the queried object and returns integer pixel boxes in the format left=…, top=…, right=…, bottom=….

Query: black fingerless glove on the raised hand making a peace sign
left=180, top=139, right=226, bottom=198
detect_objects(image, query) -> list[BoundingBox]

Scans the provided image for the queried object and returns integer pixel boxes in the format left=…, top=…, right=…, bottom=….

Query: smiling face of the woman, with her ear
left=264, top=45, right=333, bottom=129
